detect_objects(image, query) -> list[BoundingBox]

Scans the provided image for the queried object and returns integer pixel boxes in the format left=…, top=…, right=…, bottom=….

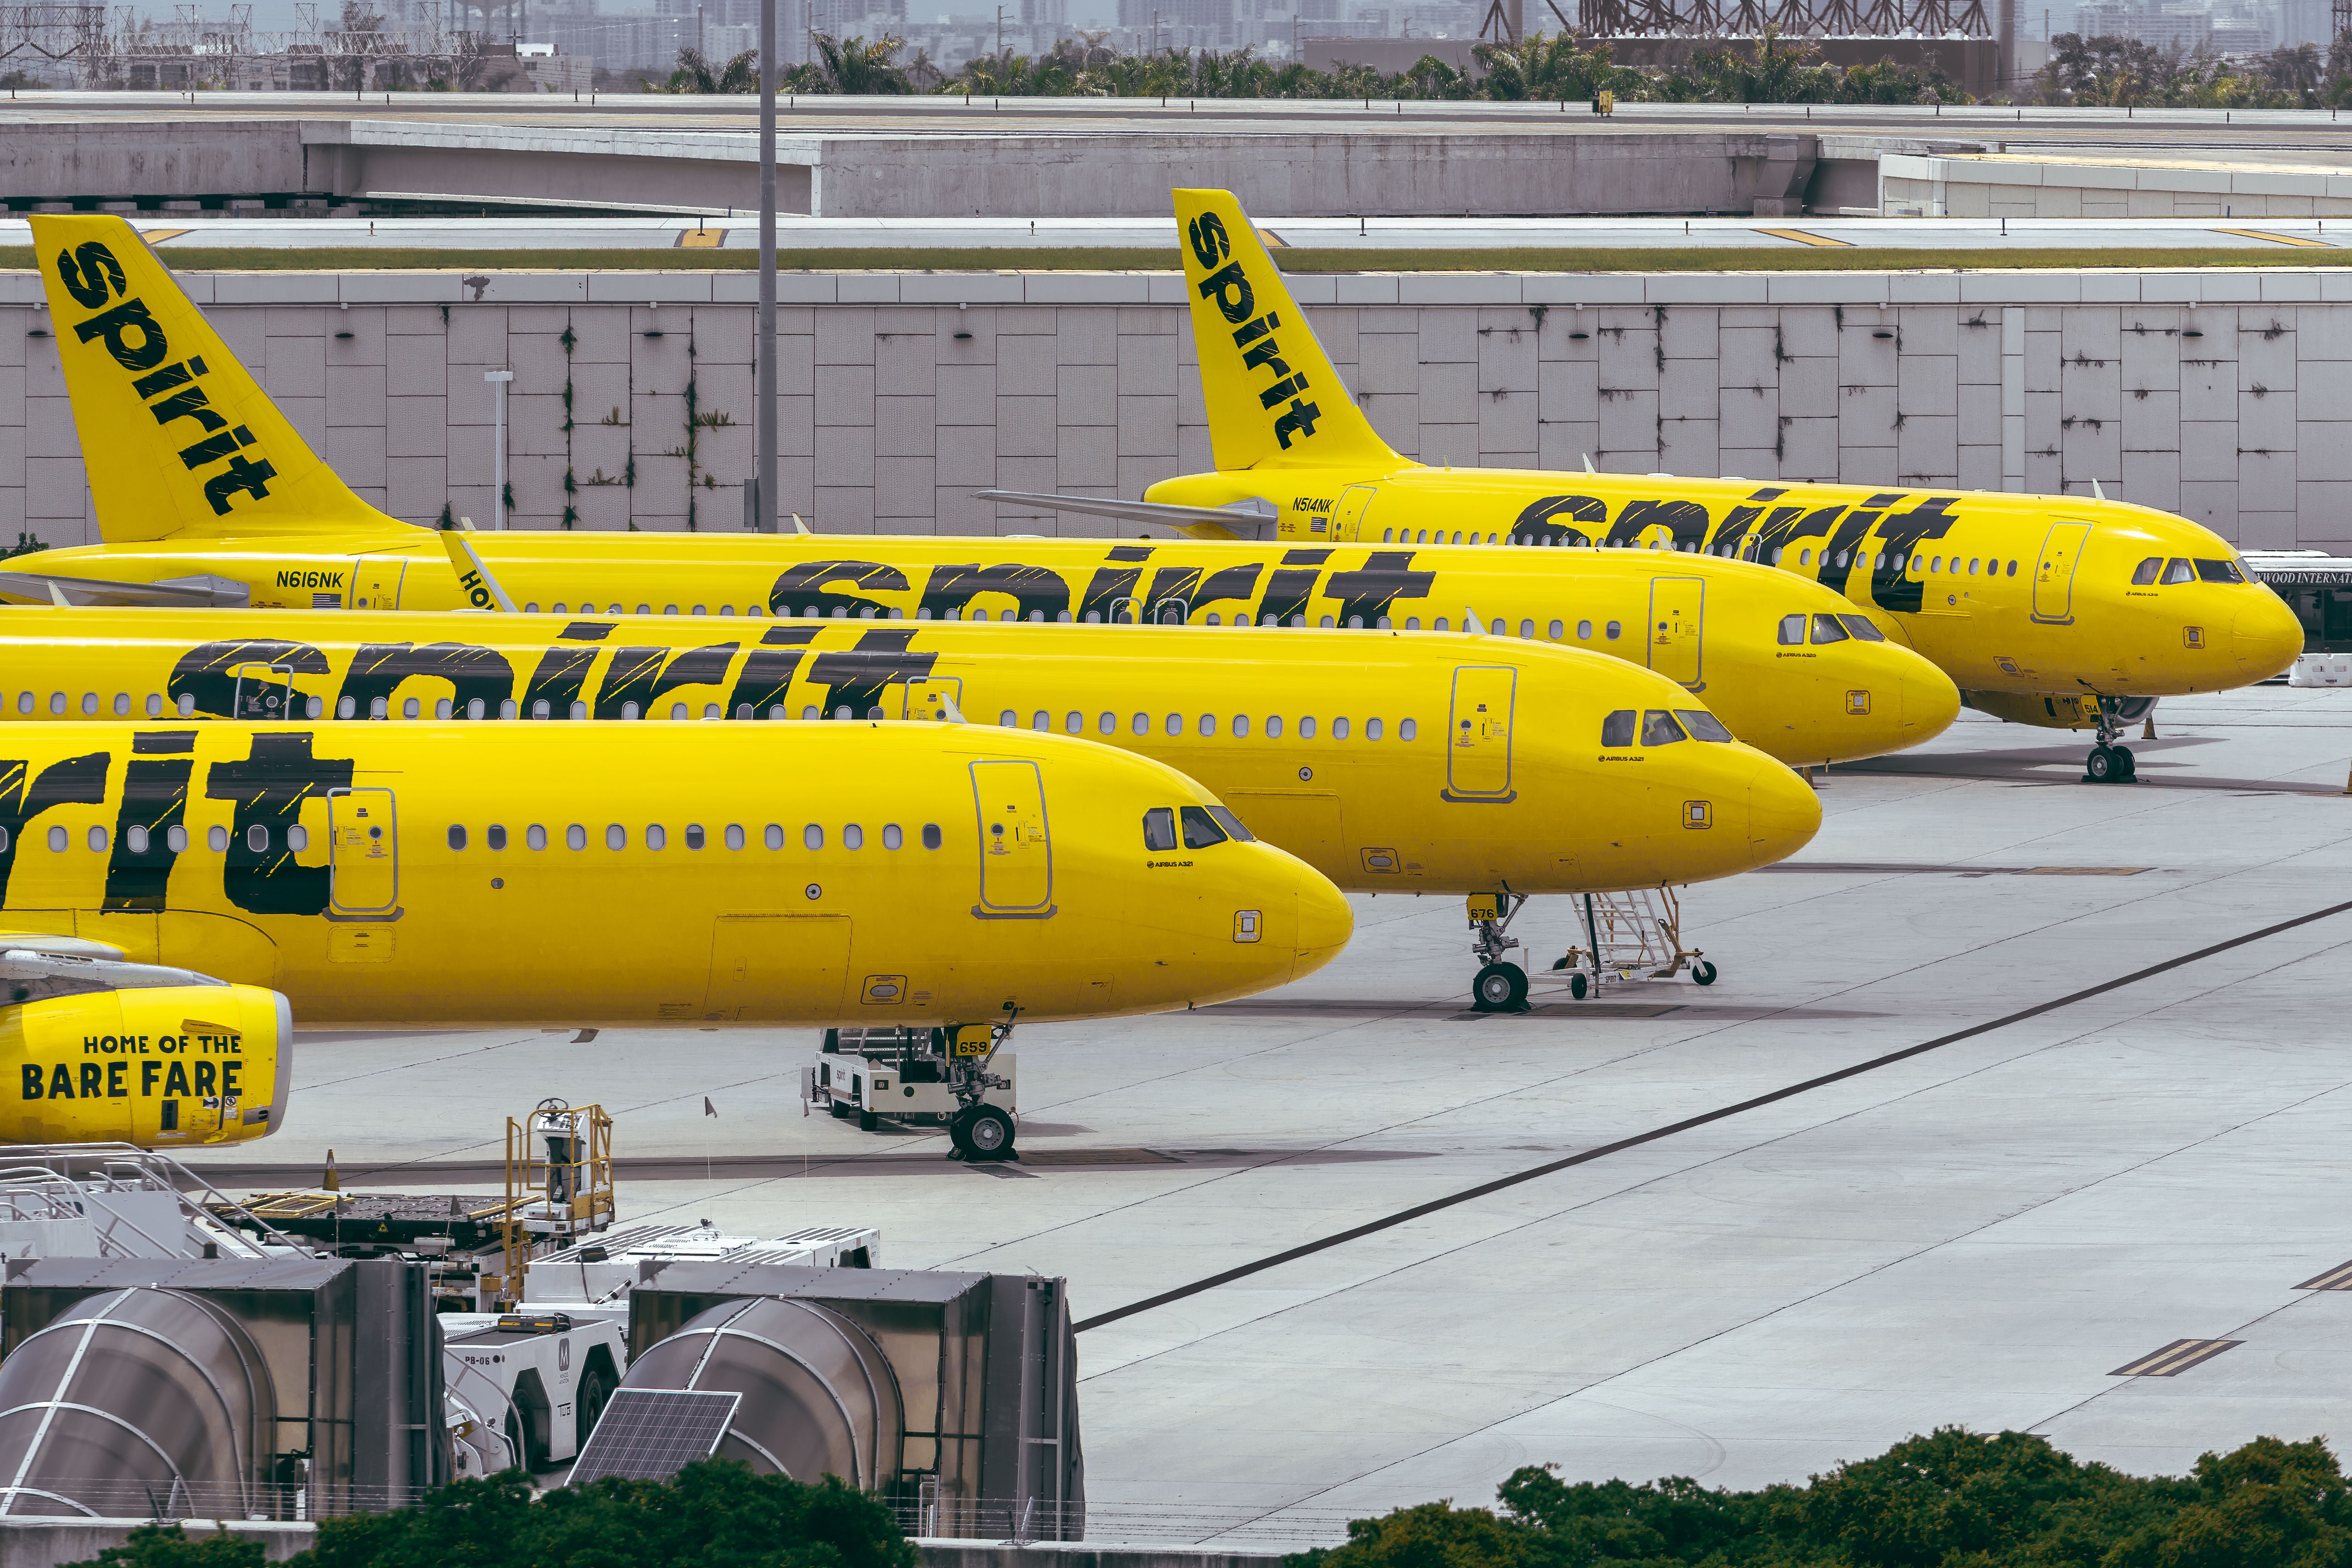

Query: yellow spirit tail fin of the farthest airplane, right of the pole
left=1176, top=190, right=1402, bottom=470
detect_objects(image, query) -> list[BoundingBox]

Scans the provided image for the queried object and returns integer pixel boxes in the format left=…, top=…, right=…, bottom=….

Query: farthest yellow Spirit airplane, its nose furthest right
left=981, top=190, right=2303, bottom=783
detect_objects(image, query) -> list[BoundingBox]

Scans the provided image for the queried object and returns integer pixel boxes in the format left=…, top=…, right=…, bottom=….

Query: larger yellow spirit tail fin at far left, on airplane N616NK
left=33, top=216, right=407, bottom=543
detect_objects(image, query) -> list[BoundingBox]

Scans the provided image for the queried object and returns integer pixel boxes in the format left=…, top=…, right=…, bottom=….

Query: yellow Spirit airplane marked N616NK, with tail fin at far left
left=18, top=216, right=1959, bottom=780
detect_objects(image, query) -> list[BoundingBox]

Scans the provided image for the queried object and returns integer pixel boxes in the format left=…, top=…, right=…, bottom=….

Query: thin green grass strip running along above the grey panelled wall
left=0, top=245, right=2352, bottom=273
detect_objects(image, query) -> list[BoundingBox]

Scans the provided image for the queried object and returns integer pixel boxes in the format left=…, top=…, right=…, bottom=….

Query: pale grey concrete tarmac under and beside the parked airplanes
left=191, top=687, right=2352, bottom=1547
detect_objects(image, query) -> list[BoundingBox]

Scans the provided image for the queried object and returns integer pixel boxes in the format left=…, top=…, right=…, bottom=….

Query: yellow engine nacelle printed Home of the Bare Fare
left=0, top=985, right=294, bottom=1150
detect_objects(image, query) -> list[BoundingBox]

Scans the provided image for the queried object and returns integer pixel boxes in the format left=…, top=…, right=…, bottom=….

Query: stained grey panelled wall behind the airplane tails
left=0, top=268, right=2352, bottom=548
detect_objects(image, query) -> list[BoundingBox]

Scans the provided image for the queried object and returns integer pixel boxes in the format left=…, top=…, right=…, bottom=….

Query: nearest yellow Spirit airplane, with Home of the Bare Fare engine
left=0, top=719, right=1352, bottom=1154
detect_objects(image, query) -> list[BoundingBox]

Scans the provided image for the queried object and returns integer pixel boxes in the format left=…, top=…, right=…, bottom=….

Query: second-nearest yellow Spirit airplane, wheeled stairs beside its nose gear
left=0, top=606, right=1820, bottom=1011
